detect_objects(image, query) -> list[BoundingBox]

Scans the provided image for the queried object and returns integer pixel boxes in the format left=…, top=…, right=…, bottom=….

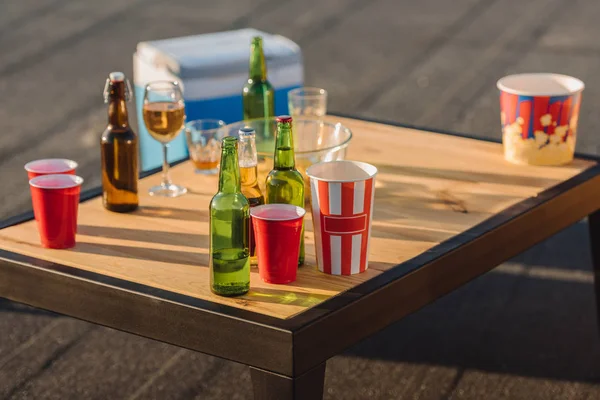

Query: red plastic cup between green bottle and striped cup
left=250, top=204, right=306, bottom=283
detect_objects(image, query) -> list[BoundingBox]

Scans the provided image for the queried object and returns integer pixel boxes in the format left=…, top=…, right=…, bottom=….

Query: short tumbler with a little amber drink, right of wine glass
left=185, top=119, right=225, bottom=175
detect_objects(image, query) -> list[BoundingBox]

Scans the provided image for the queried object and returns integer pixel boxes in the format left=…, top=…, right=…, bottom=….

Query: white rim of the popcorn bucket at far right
left=496, top=72, right=585, bottom=97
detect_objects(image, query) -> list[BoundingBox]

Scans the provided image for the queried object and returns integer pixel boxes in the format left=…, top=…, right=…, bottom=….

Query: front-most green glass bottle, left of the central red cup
left=209, top=136, right=250, bottom=296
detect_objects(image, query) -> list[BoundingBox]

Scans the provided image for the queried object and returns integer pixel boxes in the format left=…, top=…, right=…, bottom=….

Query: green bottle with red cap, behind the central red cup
left=266, top=115, right=304, bottom=265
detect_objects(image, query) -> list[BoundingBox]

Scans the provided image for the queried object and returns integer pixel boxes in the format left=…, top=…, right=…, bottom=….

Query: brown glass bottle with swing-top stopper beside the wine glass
left=100, top=72, right=138, bottom=212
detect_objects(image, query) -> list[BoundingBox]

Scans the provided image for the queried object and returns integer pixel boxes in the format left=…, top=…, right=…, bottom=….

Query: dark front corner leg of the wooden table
left=250, top=363, right=325, bottom=400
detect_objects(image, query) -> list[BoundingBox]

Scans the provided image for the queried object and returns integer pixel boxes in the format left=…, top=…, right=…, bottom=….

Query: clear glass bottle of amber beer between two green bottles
left=238, top=128, right=265, bottom=265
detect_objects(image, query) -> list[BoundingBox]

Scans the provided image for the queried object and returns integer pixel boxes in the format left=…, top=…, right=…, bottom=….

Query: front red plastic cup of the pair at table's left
left=29, top=175, right=83, bottom=249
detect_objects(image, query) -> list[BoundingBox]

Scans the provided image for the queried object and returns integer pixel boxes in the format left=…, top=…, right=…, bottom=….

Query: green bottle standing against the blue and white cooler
left=242, top=36, right=275, bottom=120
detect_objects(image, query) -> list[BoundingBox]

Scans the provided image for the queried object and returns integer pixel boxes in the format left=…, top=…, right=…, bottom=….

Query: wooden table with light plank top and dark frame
left=0, top=117, right=600, bottom=400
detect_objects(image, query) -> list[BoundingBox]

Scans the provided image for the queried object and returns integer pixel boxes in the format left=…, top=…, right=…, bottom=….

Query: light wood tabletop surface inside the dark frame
left=0, top=117, right=594, bottom=319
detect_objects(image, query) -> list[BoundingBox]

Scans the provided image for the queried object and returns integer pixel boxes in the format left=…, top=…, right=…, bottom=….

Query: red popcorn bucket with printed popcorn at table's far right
left=497, top=73, right=584, bottom=165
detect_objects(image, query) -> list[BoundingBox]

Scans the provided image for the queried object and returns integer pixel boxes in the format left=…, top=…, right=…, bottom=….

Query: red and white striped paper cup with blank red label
left=306, top=161, right=377, bottom=275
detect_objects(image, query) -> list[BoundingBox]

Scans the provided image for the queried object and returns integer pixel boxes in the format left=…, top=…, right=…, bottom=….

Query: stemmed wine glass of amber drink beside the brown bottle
left=143, top=81, right=187, bottom=197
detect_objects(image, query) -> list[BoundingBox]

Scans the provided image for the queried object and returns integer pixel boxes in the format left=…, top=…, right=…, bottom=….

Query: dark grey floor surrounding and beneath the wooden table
left=0, top=0, right=600, bottom=400
